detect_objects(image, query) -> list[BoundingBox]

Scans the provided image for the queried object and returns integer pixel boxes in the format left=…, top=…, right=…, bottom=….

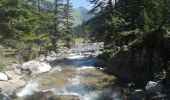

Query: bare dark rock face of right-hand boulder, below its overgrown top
left=107, top=48, right=162, bottom=85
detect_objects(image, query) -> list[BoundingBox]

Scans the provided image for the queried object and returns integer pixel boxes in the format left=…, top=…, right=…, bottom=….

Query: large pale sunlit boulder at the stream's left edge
left=22, top=60, right=51, bottom=74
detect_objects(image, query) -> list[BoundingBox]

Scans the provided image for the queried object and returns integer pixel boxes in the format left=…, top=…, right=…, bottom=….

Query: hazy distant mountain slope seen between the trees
left=72, top=7, right=94, bottom=26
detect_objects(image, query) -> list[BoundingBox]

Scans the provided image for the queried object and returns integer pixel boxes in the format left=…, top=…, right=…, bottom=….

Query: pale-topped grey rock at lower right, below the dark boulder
left=145, top=81, right=163, bottom=94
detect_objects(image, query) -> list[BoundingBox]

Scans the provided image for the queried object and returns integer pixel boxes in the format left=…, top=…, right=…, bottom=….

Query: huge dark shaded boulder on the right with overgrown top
left=107, top=30, right=170, bottom=85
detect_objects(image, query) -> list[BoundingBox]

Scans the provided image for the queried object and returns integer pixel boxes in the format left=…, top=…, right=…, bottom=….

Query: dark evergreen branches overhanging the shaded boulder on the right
left=87, top=0, right=169, bottom=46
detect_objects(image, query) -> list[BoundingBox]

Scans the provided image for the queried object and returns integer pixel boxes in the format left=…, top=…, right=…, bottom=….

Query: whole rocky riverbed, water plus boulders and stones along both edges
left=0, top=43, right=169, bottom=100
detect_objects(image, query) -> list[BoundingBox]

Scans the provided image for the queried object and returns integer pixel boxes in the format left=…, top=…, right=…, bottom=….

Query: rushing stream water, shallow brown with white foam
left=14, top=48, right=130, bottom=100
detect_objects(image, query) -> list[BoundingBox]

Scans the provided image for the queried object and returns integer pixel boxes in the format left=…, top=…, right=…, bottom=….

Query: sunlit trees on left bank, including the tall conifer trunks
left=0, top=0, right=73, bottom=65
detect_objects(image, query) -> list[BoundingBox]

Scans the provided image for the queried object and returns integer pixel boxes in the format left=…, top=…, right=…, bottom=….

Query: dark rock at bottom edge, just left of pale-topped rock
left=132, top=89, right=147, bottom=100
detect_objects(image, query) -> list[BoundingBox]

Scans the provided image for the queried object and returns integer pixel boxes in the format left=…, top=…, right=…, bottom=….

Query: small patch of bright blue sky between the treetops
left=70, top=0, right=89, bottom=8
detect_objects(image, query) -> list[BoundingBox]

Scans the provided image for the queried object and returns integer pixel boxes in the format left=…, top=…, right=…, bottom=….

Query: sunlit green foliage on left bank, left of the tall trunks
left=0, top=0, right=53, bottom=65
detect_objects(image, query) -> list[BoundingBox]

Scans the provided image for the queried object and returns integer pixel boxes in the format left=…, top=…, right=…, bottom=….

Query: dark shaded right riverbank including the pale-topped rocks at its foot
left=102, top=29, right=170, bottom=99
